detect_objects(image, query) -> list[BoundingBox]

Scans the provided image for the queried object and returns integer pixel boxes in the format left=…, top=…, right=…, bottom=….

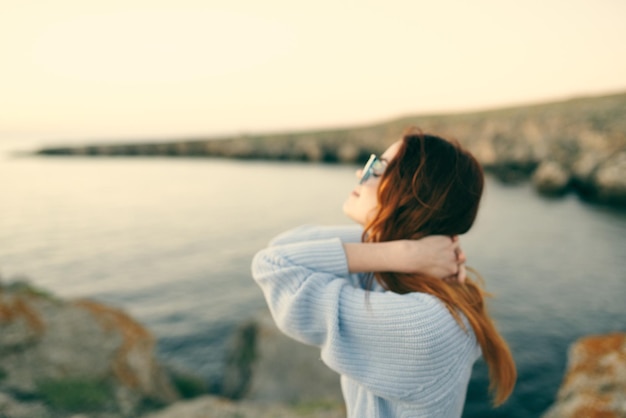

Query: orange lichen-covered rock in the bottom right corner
left=542, top=333, right=626, bottom=418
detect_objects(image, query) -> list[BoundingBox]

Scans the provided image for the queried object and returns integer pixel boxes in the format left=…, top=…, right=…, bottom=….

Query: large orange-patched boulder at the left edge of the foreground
left=0, top=283, right=178, bottom=415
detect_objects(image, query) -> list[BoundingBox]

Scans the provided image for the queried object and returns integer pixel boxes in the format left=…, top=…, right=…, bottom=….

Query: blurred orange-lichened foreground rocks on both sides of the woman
left=0, top=282, right=626, bottom=418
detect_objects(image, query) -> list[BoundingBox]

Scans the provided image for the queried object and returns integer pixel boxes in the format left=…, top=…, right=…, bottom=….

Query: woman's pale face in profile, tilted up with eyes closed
left=343, top=141, right=402, bottom=225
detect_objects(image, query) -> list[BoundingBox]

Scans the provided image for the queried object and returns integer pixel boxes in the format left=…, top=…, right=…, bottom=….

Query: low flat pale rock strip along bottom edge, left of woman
left=143, top=396, right=346, bottom=418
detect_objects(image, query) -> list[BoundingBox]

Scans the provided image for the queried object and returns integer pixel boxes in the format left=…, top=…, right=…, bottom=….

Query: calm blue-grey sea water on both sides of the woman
left=0, top=139, right=626, bottom=418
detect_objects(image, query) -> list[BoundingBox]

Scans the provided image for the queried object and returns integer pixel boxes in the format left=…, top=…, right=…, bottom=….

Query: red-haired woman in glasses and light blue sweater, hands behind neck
left=252, top=131, right=516, bottom=418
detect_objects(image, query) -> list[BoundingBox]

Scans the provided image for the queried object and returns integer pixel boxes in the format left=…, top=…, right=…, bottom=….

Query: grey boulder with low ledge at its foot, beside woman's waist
left=143, top=310, right=346, bottom=418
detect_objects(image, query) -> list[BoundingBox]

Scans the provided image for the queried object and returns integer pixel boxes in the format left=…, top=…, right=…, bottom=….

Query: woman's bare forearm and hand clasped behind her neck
left=344, top=235, right=466, bottom=283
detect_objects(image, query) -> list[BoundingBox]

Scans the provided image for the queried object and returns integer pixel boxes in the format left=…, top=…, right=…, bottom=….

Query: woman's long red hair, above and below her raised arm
left=363, top=129, right=517, bottom=406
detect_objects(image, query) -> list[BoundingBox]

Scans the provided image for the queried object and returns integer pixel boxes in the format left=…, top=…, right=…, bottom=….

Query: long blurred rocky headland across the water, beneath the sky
left=36, top=92, right=626, bottom=207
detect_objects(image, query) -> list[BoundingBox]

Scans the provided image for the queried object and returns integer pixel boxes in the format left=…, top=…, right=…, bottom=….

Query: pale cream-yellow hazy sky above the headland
left=0, top=0, right=626, bottom=138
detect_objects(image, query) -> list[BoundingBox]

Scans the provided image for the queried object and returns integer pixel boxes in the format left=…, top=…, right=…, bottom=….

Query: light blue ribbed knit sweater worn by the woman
left=252, top=226, right=480, bottom=418
